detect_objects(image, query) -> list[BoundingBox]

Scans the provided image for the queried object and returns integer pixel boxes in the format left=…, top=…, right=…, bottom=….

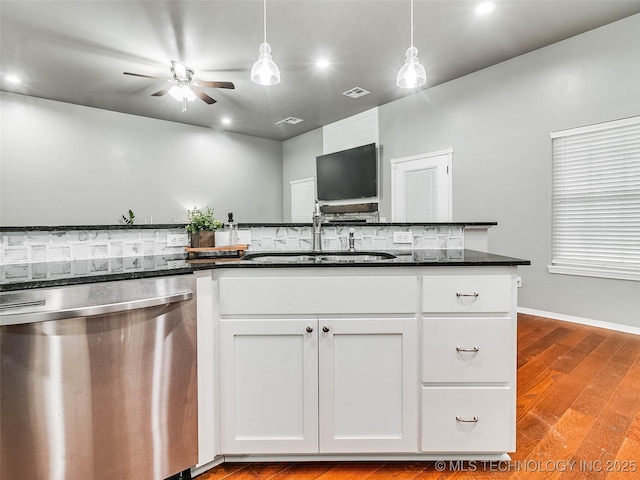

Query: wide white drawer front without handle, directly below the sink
left=220, top=276, right=418, bottom=315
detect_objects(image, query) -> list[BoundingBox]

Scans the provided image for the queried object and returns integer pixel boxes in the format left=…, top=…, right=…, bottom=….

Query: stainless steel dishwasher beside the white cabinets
left=0, top=275, right=198, bottom=480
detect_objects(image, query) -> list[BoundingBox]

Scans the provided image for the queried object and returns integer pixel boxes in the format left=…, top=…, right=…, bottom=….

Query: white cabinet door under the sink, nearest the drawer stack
left=318, top=318, right=418, bottom=453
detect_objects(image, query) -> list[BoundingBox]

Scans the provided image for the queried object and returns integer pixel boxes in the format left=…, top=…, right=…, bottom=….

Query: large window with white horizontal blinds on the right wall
left=549, top=117, right=640, bottom=280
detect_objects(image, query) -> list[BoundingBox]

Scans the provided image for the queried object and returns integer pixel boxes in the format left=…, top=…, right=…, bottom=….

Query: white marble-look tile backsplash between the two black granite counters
left=0, top=223, right=464, bottom=266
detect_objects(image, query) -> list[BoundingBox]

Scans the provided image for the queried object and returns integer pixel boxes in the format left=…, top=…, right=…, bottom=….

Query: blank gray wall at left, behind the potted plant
left=0, top=92, right=283, bottom=226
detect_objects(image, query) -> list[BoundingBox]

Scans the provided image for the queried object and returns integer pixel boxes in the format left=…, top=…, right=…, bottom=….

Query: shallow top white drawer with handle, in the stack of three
left=422, top=275, right=512, bottom=313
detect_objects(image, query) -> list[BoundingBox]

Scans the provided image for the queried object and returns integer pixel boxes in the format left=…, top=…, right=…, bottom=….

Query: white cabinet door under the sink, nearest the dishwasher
left=220, top=319, right=318, bottom=454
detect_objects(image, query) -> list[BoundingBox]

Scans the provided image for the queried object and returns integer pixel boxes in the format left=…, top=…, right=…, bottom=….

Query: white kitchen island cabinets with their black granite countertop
left=0, top=224, right=529, bottom=474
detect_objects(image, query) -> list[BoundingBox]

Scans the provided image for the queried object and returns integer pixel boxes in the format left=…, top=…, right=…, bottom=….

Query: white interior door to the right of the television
left=391, top=149, right=453, bottom=222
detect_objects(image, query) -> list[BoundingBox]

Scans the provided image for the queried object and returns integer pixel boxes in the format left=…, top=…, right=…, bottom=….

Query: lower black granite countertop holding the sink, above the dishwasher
left=0, top=249, right=531, bottom=292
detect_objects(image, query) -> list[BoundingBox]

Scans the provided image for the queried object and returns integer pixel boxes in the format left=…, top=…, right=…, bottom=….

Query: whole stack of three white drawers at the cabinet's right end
left=421, top=271, right=517, bottom=453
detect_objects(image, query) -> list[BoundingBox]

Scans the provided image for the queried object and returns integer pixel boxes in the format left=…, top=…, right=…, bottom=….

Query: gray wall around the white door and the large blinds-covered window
left=284, top=15, right=640, bottom=327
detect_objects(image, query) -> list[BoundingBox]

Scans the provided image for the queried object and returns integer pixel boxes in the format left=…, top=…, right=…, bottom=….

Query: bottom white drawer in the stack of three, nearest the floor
left=421, top=387, right=515, bottom=452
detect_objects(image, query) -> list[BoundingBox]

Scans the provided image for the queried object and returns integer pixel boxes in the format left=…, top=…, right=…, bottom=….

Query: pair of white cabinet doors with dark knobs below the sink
left=220, top=318, right=418, bottom=454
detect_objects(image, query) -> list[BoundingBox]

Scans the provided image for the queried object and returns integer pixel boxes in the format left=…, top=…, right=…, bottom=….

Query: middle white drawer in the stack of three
left=422, top=317, right=516, bottom=383
